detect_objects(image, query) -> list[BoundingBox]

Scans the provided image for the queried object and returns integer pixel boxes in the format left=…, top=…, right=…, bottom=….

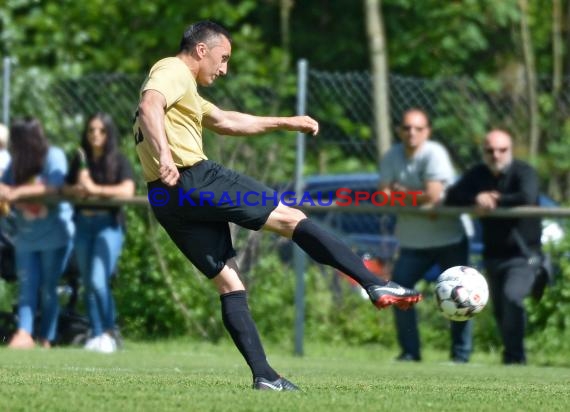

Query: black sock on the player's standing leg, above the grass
left=220, top=290, right=279, bottom=381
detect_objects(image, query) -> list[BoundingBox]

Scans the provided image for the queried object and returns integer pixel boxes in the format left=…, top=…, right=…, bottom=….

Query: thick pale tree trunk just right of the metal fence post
left=364, top=0, right=392, bottom=161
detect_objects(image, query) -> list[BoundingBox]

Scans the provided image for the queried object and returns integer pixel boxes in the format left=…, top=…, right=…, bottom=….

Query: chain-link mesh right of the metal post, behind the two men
left=308, top=71, right=570, bottom=176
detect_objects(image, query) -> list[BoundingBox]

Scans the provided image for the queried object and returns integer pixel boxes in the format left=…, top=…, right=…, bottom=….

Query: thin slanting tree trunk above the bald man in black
left=518, top=0, right=539, bottom=163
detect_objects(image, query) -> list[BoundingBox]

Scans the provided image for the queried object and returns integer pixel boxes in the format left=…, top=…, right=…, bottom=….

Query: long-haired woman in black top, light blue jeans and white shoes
left=65, top=113, right=135, bottom=353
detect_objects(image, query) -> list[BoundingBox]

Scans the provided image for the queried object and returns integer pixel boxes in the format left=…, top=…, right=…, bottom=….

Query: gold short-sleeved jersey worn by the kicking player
left=133, top=57, right=214, bottom=182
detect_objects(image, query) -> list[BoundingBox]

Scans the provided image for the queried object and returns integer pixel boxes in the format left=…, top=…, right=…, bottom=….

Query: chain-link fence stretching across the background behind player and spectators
left=0, top=59, right=570, bottom=342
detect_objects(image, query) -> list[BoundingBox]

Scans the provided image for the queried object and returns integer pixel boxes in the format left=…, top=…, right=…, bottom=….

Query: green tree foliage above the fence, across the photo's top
left=0, top=0, right=570, bottom=77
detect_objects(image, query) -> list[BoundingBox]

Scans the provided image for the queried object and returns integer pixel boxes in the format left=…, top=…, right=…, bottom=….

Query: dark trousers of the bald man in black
left=485, top=256, right=535, bottom=364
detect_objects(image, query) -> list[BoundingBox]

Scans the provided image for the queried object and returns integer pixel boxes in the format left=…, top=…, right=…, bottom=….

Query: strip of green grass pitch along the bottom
left=0, top=341, right=570, bottom=412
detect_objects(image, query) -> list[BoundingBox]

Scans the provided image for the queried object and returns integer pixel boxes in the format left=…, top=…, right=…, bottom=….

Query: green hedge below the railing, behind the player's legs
left=115, top=208, right=570, bottom=362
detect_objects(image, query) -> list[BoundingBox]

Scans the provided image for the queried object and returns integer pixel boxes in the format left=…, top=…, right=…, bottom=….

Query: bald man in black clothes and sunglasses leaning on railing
left=445, top=129, right=541, bottom=364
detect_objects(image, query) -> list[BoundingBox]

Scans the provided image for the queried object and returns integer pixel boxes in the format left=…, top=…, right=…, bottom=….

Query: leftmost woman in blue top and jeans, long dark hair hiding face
left=0, top=118, right=74, bottom=349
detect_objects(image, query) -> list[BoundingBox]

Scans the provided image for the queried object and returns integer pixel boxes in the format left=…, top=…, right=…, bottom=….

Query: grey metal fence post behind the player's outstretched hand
left=293, top=59, right=308, bottom=356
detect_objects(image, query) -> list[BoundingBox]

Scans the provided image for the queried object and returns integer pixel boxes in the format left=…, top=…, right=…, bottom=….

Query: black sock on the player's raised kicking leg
left=293, top=219, right=386, bottom=289
